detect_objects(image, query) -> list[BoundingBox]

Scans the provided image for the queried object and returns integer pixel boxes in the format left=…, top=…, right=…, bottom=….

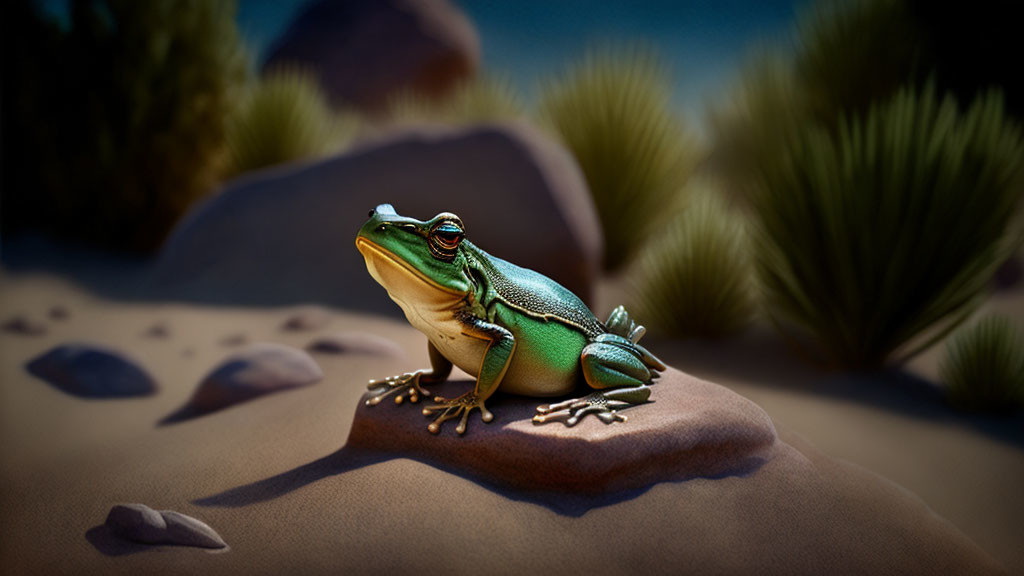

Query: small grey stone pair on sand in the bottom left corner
left=105, top=504, right=227, bottom=548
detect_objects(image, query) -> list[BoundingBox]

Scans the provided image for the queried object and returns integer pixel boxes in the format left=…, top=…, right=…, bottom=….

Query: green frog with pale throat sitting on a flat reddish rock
left=355, top=204, right=666, bottom=436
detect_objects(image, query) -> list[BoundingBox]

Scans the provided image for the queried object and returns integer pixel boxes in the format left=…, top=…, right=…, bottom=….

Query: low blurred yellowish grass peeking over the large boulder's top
left=386, top=76, right=525, bottom=125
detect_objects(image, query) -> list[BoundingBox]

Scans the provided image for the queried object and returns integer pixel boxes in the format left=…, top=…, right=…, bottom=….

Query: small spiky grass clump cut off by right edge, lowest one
left=940, top=316, right=1024, bottom=412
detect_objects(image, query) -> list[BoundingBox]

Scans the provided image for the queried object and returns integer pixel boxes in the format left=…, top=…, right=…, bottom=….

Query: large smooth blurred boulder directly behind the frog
left=152, top=119, right=601, bottom=316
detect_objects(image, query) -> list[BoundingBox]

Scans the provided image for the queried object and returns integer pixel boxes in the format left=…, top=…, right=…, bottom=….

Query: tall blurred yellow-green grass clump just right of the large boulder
left=539, top=48, right=695, bottom=270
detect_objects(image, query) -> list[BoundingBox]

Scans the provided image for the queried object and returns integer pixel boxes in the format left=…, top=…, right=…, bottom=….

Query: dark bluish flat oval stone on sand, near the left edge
left=26, top=344, right=157, bottom=398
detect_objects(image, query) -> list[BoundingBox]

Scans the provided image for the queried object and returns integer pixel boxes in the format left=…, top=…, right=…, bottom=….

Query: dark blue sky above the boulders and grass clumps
left=41, top=0, right=811, bottom=114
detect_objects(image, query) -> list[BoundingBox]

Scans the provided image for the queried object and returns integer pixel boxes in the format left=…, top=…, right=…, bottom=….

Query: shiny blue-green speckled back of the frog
left=463, top=242, right=606, bottom=337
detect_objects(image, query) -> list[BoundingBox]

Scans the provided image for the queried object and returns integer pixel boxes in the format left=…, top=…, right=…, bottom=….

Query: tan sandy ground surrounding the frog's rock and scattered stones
left=0, top=276, right=1024, bottom=574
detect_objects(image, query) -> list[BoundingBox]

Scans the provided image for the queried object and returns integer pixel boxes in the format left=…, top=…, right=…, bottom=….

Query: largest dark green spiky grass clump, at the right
left=753, top=89, right=1024, bottom=367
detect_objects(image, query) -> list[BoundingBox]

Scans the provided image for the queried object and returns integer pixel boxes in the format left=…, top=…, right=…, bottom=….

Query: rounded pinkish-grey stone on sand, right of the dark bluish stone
left=163, top=342, right=324, bottom=423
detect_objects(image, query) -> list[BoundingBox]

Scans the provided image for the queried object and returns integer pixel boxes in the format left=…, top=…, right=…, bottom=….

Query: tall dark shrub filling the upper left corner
left=4, top=0, right=246, bottom=250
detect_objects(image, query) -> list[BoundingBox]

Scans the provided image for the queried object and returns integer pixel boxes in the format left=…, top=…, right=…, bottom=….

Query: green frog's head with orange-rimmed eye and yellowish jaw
left=355, top=204, right=470, bottom=300
